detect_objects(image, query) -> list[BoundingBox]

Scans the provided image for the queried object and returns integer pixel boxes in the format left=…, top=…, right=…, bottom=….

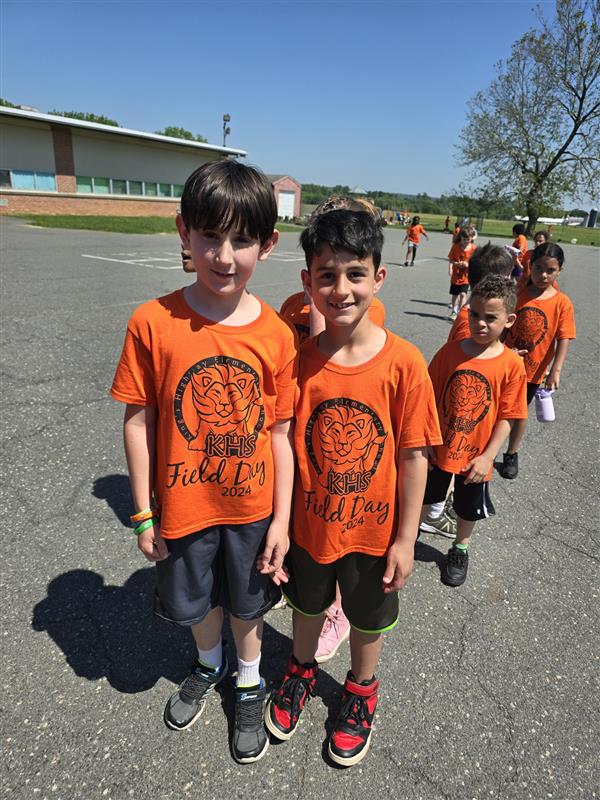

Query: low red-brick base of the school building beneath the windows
left=0, top=190, right=179, bottom=217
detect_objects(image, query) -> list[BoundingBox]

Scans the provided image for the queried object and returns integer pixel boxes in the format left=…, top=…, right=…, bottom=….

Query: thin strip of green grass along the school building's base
left=11, top=214, right=302, bottom=233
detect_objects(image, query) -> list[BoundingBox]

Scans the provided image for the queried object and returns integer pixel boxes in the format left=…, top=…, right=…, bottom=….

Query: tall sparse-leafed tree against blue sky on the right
left=458, top=0, right=600, bottom=234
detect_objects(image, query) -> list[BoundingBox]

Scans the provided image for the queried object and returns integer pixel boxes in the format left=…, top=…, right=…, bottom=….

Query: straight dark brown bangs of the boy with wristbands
left=181, top=159, right=277, bottom=245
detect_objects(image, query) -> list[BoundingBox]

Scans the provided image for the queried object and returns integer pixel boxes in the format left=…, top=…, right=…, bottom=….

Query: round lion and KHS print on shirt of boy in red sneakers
left=305, top=397, right=387, bottom=495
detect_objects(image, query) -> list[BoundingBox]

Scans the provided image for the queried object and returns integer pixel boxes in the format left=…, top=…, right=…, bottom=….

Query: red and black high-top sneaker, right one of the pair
left=328, top=672, right=379, bottom=767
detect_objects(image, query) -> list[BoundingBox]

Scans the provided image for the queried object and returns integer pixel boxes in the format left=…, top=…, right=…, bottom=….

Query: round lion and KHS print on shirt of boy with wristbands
left=175, top=356, right=264, bottom=457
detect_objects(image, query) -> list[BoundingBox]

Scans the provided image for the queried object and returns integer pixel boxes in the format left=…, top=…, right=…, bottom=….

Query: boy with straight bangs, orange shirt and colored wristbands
left=111, top=160, right=297, bottom=763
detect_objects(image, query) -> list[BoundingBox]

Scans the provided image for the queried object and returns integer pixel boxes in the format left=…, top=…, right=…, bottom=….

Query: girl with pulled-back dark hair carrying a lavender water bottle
left=501, top=242, right=576, bottom=480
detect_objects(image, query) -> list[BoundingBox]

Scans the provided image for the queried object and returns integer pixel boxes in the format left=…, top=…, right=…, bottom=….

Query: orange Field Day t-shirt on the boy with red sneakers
left=292, top=331, right=441, bottom=564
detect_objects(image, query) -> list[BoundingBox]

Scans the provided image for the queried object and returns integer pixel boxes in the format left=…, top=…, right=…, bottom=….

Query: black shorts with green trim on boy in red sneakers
left=282, top=541, right=398, bottom=633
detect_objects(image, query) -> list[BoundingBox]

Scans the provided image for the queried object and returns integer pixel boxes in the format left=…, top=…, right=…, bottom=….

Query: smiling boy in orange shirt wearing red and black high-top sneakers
left=265, top=211, right=441, bottom=766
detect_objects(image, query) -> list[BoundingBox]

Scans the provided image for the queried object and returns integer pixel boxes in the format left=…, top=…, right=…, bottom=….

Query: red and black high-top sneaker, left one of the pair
left=265, top=656, right=318, bottom=741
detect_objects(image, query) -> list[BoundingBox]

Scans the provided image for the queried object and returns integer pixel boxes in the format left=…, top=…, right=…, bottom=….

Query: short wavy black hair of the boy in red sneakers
left=300, top=209, right=383, bottom=272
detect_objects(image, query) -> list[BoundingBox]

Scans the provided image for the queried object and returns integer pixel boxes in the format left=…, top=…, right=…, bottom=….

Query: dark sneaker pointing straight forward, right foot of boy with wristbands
left=231, top=680, right=269, bottom=764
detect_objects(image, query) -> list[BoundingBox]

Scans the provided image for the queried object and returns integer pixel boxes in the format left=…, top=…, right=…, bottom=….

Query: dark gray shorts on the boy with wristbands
left=154, top=517, right=281, bottom=625
